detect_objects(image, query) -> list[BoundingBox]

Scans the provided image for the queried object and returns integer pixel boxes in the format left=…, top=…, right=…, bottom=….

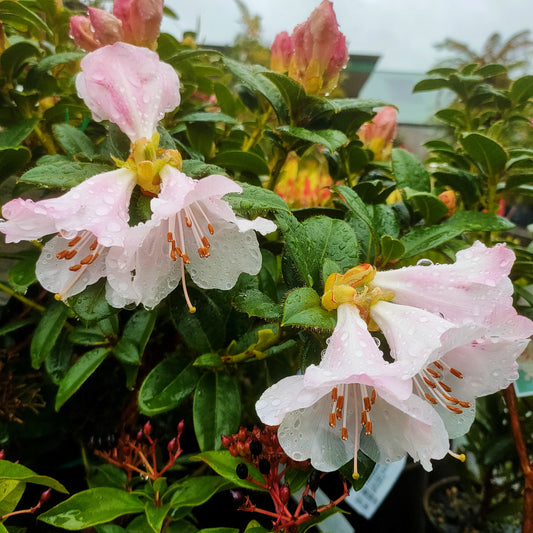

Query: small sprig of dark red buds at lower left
left=94, top=420, right=185, bottom=481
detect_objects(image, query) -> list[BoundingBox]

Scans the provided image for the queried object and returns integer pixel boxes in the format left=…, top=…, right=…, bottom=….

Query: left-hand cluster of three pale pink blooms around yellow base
left=0, top=42, right=275, bottom=312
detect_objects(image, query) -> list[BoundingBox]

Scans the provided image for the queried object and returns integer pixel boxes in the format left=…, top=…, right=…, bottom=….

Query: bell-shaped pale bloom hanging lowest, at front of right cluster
left=256, top=304, right=449, bottom=477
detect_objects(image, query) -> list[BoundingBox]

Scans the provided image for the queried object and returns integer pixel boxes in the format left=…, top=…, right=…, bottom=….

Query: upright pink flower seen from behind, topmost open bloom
left=76, top=42, right=180, bottom=142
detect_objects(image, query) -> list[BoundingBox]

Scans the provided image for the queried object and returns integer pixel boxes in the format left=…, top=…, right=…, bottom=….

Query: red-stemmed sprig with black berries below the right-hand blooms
left=222, top=426, right=349, bottom=532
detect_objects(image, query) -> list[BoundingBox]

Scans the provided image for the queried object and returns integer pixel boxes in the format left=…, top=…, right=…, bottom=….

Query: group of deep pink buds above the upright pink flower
left=70, top=0, right=164, bottom=52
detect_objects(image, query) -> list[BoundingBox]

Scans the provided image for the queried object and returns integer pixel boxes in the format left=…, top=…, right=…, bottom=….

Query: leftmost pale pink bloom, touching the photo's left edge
left=0, top=169, right=135, bottom=299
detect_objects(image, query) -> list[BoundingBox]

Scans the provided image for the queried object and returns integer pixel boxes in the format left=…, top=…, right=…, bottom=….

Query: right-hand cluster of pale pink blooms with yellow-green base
left=256, top=242, right=533, bottom=477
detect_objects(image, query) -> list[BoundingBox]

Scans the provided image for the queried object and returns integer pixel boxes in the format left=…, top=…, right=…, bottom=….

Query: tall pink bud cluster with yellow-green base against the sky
left=270, top=0, right=348, bottom=95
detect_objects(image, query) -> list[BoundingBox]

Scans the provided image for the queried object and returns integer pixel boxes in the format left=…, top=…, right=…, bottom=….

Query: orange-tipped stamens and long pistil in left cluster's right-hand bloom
left=167, top=202, right=215, bottom=313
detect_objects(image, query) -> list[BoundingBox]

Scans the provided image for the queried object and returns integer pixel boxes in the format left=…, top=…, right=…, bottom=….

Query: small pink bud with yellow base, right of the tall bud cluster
left=357, top=106, right=398, bottom=161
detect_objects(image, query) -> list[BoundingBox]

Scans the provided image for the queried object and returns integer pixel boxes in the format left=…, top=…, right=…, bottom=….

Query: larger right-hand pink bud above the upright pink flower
left=113, top=0, right=164, bottom=49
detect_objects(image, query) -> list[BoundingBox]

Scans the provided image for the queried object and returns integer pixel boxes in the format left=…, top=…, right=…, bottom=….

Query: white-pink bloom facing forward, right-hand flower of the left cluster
left=107, top=166, right=276, bottom=312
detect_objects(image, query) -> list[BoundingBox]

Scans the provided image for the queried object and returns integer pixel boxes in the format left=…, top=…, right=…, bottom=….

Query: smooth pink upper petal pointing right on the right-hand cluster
left=373, top=242, right=514, bottom=324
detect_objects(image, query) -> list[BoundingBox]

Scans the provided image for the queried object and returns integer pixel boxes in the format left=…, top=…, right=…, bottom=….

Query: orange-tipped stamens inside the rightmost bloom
left=413, top=361, right=472, bottom=415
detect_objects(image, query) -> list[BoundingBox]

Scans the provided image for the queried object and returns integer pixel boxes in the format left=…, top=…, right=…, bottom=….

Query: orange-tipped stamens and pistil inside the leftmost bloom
left=54, top=231, right=104, bottom=300
